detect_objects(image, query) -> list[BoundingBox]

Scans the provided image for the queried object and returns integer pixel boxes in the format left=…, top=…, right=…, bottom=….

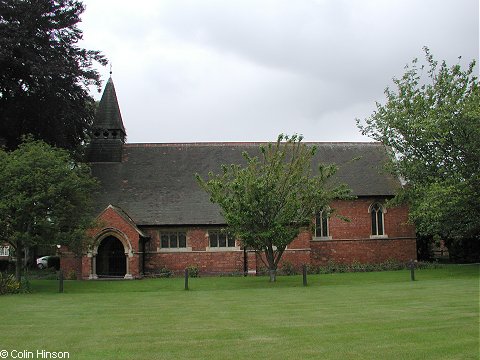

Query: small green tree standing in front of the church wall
left=196, top=135, right=349, bottom=281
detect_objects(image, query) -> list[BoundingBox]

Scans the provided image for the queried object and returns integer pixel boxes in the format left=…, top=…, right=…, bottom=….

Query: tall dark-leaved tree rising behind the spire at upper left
left=0, top=0, right=106, bottom=157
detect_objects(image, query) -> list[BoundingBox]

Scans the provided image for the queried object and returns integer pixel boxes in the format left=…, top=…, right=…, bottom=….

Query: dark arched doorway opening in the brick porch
left=96, top=235, right=127, bottom=277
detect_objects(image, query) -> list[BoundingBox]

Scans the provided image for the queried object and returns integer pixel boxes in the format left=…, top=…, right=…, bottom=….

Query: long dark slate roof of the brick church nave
left=92, top=143, right=400, bottom=226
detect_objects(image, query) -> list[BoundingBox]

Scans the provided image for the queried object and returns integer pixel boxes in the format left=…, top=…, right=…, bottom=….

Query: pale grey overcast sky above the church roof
left=80, top=0, right=479, bottom=142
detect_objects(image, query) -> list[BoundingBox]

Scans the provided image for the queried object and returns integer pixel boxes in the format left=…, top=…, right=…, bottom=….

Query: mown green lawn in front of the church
left=0, top=265, right=479, bottom=360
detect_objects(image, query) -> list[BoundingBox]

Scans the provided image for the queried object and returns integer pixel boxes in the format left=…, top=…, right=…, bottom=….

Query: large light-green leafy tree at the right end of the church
left=357, top=48, right=480, bottom=262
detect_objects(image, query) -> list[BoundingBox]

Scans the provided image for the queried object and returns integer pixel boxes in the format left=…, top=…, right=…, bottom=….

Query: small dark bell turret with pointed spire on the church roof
left=87, top=76, right=127, bottom=162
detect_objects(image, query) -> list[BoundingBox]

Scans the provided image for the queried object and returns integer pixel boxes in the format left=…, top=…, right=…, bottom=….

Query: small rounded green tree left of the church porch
left=0, top=139, right=96, bottom=280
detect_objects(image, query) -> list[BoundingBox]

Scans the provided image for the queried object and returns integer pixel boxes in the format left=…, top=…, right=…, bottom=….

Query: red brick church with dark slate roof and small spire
left=61, top=78, right=416, bottom=279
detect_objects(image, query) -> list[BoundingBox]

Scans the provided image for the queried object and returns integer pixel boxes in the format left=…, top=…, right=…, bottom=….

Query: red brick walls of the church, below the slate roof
left=71, top=197, right=416, bottom=278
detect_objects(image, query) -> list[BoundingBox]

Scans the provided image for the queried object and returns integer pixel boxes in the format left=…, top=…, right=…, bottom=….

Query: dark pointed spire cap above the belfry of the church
left=93, top=76, right=126, bottom=140
